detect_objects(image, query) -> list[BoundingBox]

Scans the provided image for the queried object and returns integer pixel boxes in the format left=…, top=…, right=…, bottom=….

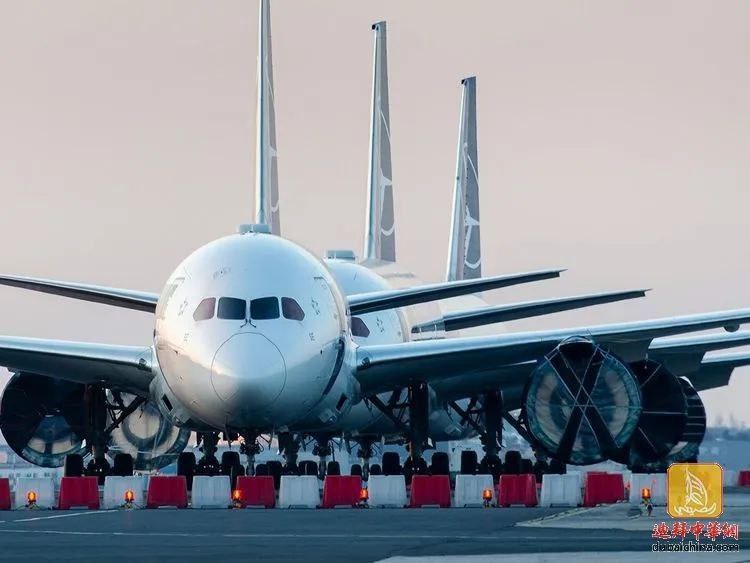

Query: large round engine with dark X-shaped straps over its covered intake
left=521, top=338, right=641, bottom=465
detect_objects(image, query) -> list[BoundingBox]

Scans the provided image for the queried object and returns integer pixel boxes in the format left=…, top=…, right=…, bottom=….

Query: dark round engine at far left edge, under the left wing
left=0, top=372, right=87, bottom=467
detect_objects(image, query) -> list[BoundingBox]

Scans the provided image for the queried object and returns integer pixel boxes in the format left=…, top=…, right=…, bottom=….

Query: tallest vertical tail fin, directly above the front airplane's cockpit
left=255, top=0, right=281, bottom=235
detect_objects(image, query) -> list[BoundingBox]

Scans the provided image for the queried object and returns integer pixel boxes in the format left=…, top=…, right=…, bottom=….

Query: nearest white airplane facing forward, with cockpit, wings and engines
left=0, top=2, right=750, bottom=484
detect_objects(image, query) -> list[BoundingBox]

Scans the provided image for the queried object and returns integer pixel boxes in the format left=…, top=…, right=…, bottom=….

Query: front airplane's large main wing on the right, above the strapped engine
left=357, top=309, right=750, bottom=394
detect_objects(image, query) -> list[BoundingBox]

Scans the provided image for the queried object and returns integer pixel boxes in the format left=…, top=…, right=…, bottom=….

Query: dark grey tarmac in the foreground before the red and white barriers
left=0, top=507, right=676, bottom=563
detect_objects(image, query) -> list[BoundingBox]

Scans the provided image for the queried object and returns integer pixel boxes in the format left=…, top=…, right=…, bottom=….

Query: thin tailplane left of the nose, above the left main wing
left=0, top=276, right=159, bottom=313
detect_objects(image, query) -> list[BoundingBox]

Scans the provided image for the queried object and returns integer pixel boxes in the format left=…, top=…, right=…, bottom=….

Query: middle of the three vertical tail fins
left=363, top=22, right=396, bottom=262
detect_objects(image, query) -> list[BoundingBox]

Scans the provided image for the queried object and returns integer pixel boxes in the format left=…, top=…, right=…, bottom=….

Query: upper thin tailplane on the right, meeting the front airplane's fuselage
left=347, top=269, right=565, bottom=315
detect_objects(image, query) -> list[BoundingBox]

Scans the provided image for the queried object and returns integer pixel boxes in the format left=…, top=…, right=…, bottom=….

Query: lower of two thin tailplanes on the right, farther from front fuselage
left=411, top=289, right=648, bottom=333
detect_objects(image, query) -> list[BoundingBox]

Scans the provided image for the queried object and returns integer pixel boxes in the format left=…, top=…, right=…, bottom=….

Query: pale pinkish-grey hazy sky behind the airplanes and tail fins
left=0, top=0, right=750, bottom=422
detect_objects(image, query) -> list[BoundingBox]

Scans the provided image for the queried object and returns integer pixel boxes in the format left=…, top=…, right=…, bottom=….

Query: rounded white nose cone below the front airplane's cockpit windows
left=211, top=332, right=286, bottom=409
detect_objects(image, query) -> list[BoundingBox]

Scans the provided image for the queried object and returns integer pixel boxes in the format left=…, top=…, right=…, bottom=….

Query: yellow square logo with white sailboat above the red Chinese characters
left=667, top=463, right=723, bottom=518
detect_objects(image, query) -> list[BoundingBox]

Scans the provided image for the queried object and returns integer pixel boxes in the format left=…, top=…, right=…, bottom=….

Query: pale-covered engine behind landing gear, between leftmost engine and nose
left=107, top=391, right=190, bottom=471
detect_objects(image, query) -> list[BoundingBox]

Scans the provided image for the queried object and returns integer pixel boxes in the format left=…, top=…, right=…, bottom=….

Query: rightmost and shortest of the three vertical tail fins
left=446, top=76, right=482, bottom=281
